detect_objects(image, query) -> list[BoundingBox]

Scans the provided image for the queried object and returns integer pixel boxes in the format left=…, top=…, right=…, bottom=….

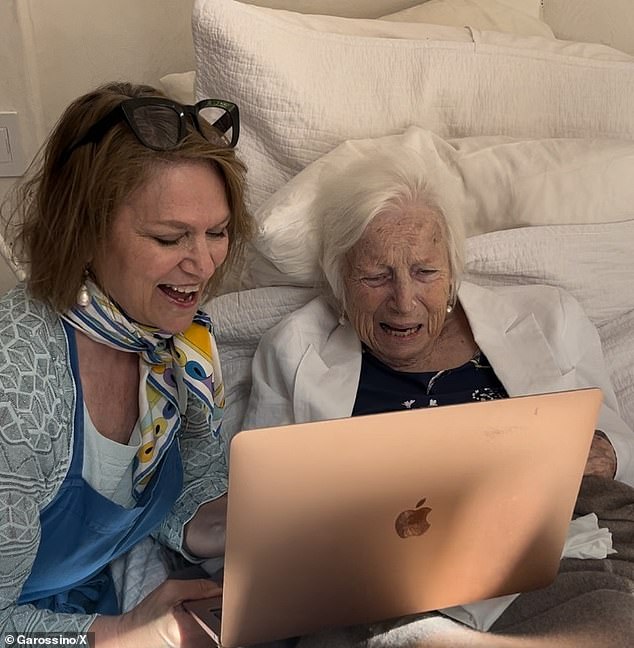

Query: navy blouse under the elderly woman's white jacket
left=352, top=348, right=508, bottom=416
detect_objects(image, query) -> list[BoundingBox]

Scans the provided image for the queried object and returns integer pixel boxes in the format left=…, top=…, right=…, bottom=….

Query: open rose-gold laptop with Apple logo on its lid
left=186, top=389, right=601, bottom=648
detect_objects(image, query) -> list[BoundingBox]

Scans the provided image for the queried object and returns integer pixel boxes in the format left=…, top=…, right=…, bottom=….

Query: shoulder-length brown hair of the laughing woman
left=2, top=83, right=253, bottom=312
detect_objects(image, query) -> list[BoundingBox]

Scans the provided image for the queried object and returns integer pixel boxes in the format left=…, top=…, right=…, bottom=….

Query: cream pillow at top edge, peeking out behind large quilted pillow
left=381, top=0, right=555, bottom=38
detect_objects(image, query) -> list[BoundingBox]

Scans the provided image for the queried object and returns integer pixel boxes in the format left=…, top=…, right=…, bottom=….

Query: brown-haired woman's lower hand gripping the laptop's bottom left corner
left=89, top=579, right=217, bottom=648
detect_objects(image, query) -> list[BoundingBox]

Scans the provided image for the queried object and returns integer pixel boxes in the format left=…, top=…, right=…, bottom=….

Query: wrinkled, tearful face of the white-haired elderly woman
left=344, top=206, right=451, bottom=371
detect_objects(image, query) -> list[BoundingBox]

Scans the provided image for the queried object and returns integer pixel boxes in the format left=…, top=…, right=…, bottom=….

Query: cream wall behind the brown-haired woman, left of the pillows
left=0, top=0, right=194, bottom=294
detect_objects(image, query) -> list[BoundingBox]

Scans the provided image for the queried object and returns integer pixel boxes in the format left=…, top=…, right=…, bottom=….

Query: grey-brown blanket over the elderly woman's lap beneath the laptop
left=299, top=477, right=634, bottom=648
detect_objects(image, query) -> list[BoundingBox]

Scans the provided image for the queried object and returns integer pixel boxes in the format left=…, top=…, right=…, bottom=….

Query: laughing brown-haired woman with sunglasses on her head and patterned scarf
left=0, top=83, right=251, bottom=648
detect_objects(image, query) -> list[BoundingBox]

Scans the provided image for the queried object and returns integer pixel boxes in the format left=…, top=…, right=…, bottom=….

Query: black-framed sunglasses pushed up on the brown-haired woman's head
left=64, top=97, right=240, bottom=160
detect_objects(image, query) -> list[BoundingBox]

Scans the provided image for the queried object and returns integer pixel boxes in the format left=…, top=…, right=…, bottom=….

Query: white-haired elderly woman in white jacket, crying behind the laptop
left=245, top=150, right=634, bottom=646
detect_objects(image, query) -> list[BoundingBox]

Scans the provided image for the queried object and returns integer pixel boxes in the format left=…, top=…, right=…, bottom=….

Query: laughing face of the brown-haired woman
left=91, top=162, right=230, bottom=333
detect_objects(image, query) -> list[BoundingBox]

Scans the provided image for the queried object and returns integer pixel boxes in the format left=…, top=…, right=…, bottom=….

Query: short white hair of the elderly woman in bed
left=320, top=147, right=465, bottom=310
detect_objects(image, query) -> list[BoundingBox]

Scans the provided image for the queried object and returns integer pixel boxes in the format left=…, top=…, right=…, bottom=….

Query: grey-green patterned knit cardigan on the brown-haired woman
left=0, top=284, right=227, bottom=633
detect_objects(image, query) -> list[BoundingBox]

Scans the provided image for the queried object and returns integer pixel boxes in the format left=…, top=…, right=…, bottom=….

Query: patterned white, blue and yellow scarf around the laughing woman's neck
left=62, top=281, right=224, bottom=499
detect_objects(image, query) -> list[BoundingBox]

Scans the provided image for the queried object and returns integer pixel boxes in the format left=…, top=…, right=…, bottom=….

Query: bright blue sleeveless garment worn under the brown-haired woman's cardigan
left=18, top=323, right=183, bottom=615
